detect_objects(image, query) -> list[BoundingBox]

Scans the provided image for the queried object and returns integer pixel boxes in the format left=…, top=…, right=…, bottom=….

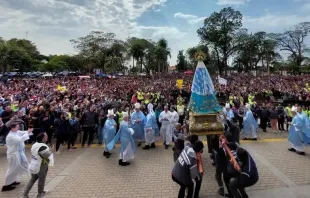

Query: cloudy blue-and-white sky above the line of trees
left=0, top=0, right=310, bottom=65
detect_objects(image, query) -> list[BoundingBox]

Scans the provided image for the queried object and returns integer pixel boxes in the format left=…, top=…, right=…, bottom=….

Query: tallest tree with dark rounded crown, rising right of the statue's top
left=197, top=7, right=242, bottom=74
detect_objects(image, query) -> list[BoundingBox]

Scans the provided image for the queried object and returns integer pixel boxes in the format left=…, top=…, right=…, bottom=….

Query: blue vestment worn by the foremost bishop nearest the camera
left=108, top=121, right=136, bottom=153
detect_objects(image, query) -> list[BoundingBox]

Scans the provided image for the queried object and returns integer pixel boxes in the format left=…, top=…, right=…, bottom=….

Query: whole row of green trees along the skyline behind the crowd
left=0, top=7, right=310, bottom=74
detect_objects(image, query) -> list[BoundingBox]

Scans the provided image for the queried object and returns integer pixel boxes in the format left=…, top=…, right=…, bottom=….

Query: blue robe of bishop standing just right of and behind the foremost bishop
left=130, top=111, right=146, bottom=140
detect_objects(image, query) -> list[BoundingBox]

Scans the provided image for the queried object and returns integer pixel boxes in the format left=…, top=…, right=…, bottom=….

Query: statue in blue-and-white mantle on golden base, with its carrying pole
left=188, top=52, right=240, bottom=171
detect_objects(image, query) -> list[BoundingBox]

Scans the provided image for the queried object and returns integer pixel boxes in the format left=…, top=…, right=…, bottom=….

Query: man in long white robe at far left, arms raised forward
left=2, top=123, right=33, bottom=191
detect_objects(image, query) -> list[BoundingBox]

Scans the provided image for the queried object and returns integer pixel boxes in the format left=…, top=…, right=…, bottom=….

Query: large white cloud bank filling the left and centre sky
left=0, top=0, right=185, bottom=58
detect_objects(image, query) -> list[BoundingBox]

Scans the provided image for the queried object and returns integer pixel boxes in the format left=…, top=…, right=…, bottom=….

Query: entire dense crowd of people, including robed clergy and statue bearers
left=0, top=74, right=310, bottom=198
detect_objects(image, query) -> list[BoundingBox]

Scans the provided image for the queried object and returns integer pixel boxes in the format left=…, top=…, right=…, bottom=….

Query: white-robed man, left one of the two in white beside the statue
left=159, top=105, right=172, bottom=149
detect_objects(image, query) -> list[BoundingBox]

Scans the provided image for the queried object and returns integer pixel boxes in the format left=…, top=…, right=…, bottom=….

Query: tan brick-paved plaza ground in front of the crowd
left=0, top=133, right=310, bottom=198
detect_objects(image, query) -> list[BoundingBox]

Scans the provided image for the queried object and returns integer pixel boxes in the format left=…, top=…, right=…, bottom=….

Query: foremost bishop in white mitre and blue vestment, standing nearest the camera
left=108, top=112, right=136, bottom=166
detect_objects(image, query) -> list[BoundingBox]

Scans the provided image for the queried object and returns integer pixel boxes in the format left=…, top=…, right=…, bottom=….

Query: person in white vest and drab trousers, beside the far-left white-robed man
left=23, top=133, right=54, bottom=198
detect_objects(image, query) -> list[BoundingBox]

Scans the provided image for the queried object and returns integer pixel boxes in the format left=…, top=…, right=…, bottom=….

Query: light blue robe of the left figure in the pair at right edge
left=288, top=115, right=304, bottom=147
